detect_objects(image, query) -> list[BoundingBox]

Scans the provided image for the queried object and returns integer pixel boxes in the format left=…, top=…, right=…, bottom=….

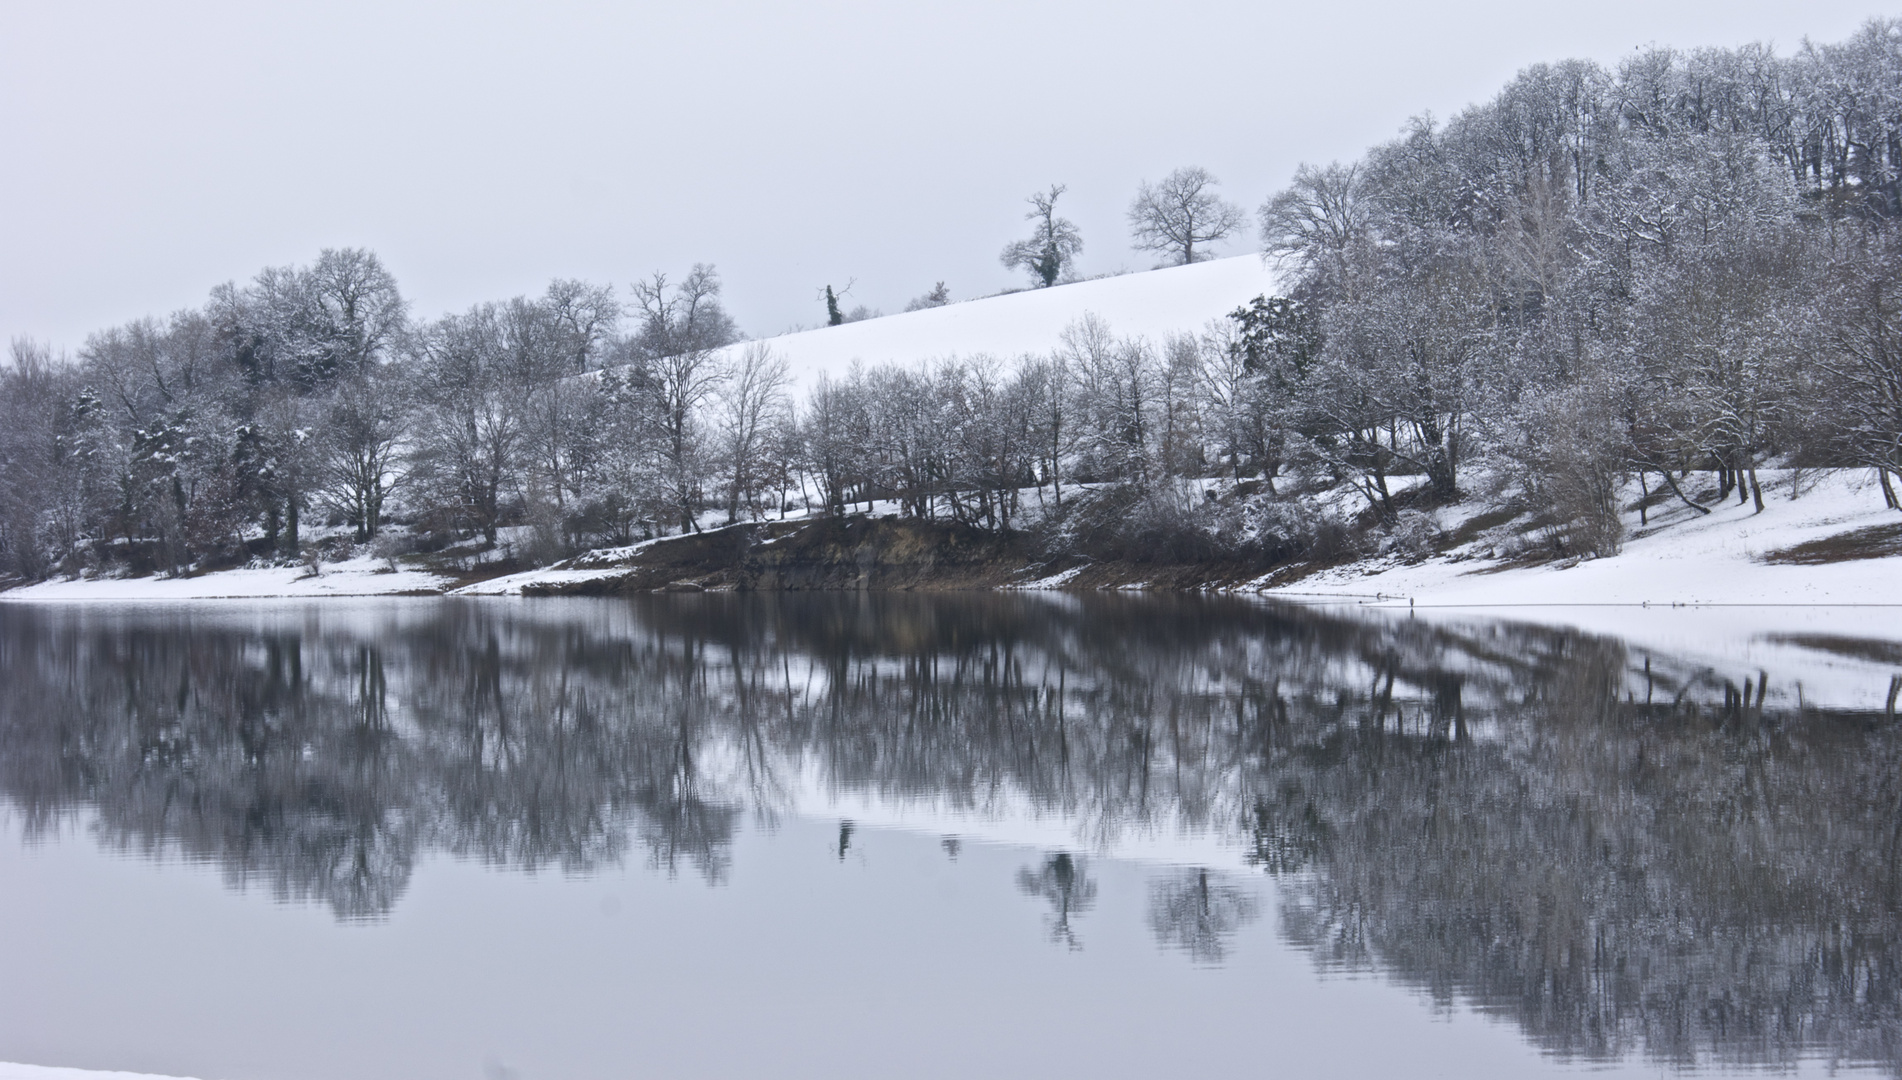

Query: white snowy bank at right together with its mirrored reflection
left=1263, top=472, right=1902, bottom=709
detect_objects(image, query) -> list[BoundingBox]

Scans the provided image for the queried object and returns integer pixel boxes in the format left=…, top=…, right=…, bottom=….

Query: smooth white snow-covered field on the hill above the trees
left=734, top=255, right=1276, bottom=386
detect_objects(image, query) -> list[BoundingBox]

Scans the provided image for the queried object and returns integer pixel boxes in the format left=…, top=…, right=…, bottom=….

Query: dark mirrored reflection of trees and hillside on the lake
left=0, top=595, right=1902, bottom=1069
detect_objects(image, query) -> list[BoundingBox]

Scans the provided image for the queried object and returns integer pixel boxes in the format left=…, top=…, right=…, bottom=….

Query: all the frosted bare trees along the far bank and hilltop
left=0, top=19, right=1902, bottom=582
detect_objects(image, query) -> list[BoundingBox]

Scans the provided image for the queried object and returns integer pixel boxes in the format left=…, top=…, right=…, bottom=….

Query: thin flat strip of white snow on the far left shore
left=0, top=557, right=447, bottom=604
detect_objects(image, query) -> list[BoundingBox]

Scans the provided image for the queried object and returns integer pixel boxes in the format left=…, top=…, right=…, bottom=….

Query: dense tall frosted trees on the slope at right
left=1250, top=19, right=1902, bottom=551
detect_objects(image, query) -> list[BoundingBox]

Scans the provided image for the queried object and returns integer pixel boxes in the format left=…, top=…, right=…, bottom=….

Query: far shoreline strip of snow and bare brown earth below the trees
left=14, top=472, right=1902, bottom=612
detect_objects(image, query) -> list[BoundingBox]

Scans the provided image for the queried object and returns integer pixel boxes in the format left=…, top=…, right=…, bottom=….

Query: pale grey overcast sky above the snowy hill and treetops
left=0, top=0, right=1883, bottom=348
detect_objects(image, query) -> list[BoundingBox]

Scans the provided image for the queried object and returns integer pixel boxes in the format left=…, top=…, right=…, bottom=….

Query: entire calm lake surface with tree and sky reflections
left=0, top=595, right=1902, bottom=1080
